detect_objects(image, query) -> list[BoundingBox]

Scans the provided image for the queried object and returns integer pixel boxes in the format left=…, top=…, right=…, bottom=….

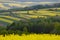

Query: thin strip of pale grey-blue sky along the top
left=0, top=0, right=60, bottom=2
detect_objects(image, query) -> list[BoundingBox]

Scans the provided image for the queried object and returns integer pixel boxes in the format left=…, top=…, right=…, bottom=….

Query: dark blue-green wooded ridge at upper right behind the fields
left=24, top=3, right=60, bottom=10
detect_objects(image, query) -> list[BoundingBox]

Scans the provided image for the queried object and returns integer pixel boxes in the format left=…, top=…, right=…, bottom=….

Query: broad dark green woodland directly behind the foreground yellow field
left=0, top=16, right=60, bottom=34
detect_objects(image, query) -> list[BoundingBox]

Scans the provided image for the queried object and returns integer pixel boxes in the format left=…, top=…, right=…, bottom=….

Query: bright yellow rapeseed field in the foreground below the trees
left=0, top=34, right=60, bottom=40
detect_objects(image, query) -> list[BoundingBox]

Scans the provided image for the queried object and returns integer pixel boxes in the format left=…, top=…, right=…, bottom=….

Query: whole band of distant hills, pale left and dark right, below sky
left=0, top=3, right=60, bottom=10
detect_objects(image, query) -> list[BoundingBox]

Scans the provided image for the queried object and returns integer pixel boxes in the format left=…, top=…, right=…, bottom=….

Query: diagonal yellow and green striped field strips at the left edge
left=0, top=15, right=20, bottom=27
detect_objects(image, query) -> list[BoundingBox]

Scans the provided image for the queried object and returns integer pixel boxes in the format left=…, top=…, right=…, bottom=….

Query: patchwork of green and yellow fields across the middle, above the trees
left=0, top=8, right=60, bottom=26
